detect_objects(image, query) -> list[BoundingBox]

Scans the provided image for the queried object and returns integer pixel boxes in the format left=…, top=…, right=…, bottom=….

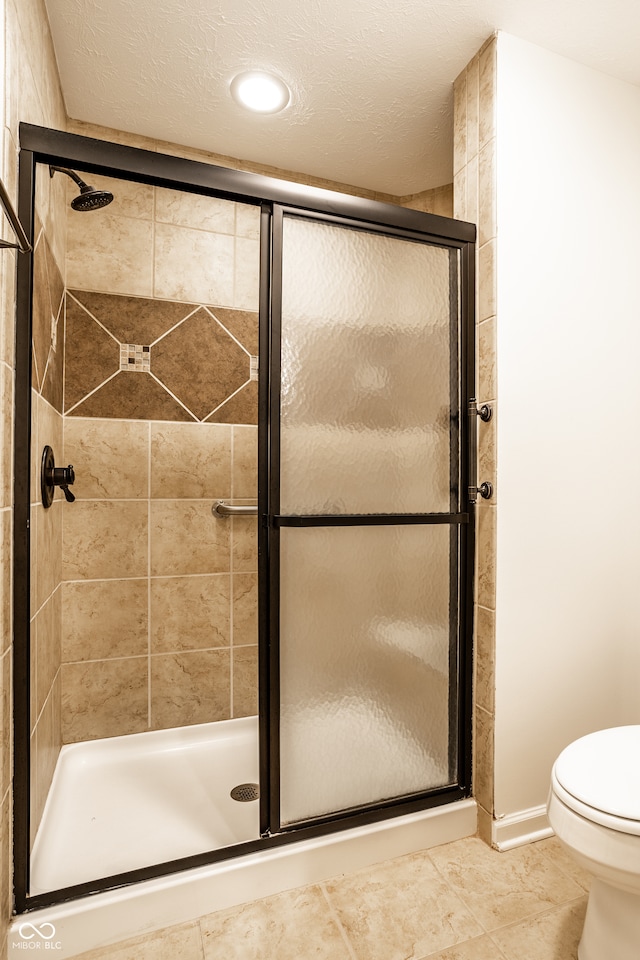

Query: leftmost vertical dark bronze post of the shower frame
left=13, top=150, right=35, bottom=912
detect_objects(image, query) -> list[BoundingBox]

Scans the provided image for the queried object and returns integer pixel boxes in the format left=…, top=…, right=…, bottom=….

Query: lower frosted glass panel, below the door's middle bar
left=280, top=525, right=457, bottom=823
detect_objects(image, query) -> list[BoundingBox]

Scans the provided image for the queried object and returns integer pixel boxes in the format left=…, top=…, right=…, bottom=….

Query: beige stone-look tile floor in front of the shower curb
left=71, top=837, right=590, bottom=960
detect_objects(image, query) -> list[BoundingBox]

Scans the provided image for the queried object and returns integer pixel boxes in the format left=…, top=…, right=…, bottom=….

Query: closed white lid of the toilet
left=554, top=725, right=640, bottom=833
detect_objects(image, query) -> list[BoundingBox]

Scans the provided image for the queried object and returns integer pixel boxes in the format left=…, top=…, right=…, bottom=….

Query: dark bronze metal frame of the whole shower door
left=14, top=124, right=476, bottom=913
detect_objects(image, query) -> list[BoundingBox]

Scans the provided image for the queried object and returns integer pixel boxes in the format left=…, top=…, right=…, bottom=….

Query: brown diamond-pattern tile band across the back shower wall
left=67, top=290, right=258, bottom=425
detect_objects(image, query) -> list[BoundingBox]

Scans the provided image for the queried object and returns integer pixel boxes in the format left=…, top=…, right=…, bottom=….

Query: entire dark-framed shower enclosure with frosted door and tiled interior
left=14, top=125, right=475, bottom=912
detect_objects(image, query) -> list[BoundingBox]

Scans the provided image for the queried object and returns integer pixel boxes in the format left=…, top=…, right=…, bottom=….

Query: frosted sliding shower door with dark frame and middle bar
left=262, top=208, right=468, bottom=831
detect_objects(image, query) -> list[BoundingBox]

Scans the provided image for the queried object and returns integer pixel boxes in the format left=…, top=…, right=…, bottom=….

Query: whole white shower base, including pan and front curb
left=8, top=717, right=477, bottom=960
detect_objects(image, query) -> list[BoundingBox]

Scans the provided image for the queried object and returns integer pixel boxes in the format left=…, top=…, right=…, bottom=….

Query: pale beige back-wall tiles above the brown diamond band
left=67, top=175, right=260, bottom=310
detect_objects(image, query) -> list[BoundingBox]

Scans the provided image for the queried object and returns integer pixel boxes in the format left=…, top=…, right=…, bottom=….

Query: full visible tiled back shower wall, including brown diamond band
left=62, top=184, right=259, bottom=742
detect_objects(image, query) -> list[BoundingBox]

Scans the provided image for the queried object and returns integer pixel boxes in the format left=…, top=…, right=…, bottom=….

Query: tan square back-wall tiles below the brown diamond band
left=62, top=417, right=257, bottom=742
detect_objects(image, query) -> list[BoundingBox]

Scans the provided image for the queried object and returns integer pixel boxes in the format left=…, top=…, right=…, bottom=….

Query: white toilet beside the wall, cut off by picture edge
left=548, top=725, right=640, bottom=960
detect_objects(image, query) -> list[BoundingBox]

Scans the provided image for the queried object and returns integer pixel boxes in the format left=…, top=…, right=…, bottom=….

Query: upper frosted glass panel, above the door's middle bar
left=281, top=217, right=458, bottom=515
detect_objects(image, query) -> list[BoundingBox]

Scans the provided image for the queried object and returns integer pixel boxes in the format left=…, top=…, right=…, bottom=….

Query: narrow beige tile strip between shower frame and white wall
left=454, top=37, right=498, bottom=842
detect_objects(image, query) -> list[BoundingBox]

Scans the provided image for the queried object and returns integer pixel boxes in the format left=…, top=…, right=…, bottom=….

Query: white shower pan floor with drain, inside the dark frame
left=31, top=717, right=260, bottom=894
